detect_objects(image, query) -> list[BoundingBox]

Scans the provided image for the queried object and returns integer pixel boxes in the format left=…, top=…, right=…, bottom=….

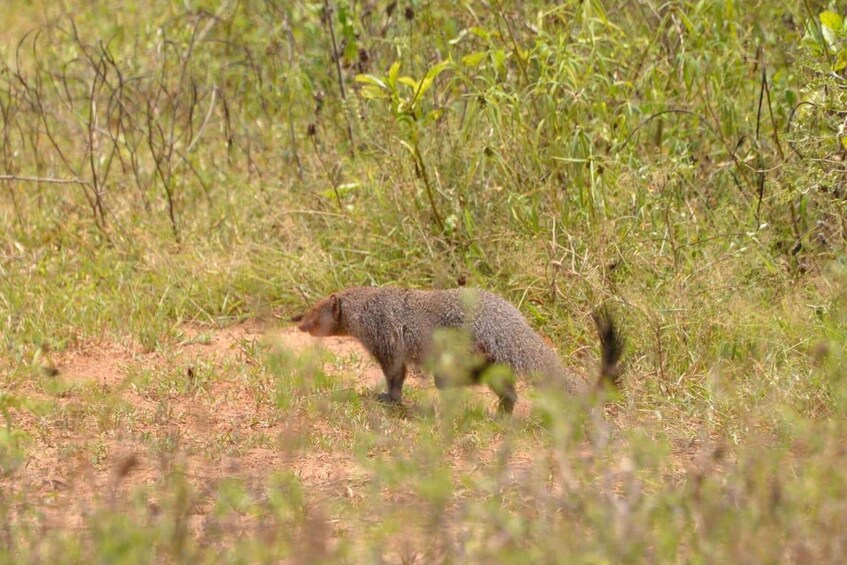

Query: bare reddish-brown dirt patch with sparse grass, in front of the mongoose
left=2, top=323, right=544, bottom=529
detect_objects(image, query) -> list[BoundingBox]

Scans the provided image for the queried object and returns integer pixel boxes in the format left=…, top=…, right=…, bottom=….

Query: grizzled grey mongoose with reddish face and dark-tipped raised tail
left=292, top=287, right=623, bottom=413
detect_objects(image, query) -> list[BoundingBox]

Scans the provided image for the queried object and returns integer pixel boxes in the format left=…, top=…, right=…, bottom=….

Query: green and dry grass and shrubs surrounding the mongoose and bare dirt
left=0, top=0, right=847, bottom=562
